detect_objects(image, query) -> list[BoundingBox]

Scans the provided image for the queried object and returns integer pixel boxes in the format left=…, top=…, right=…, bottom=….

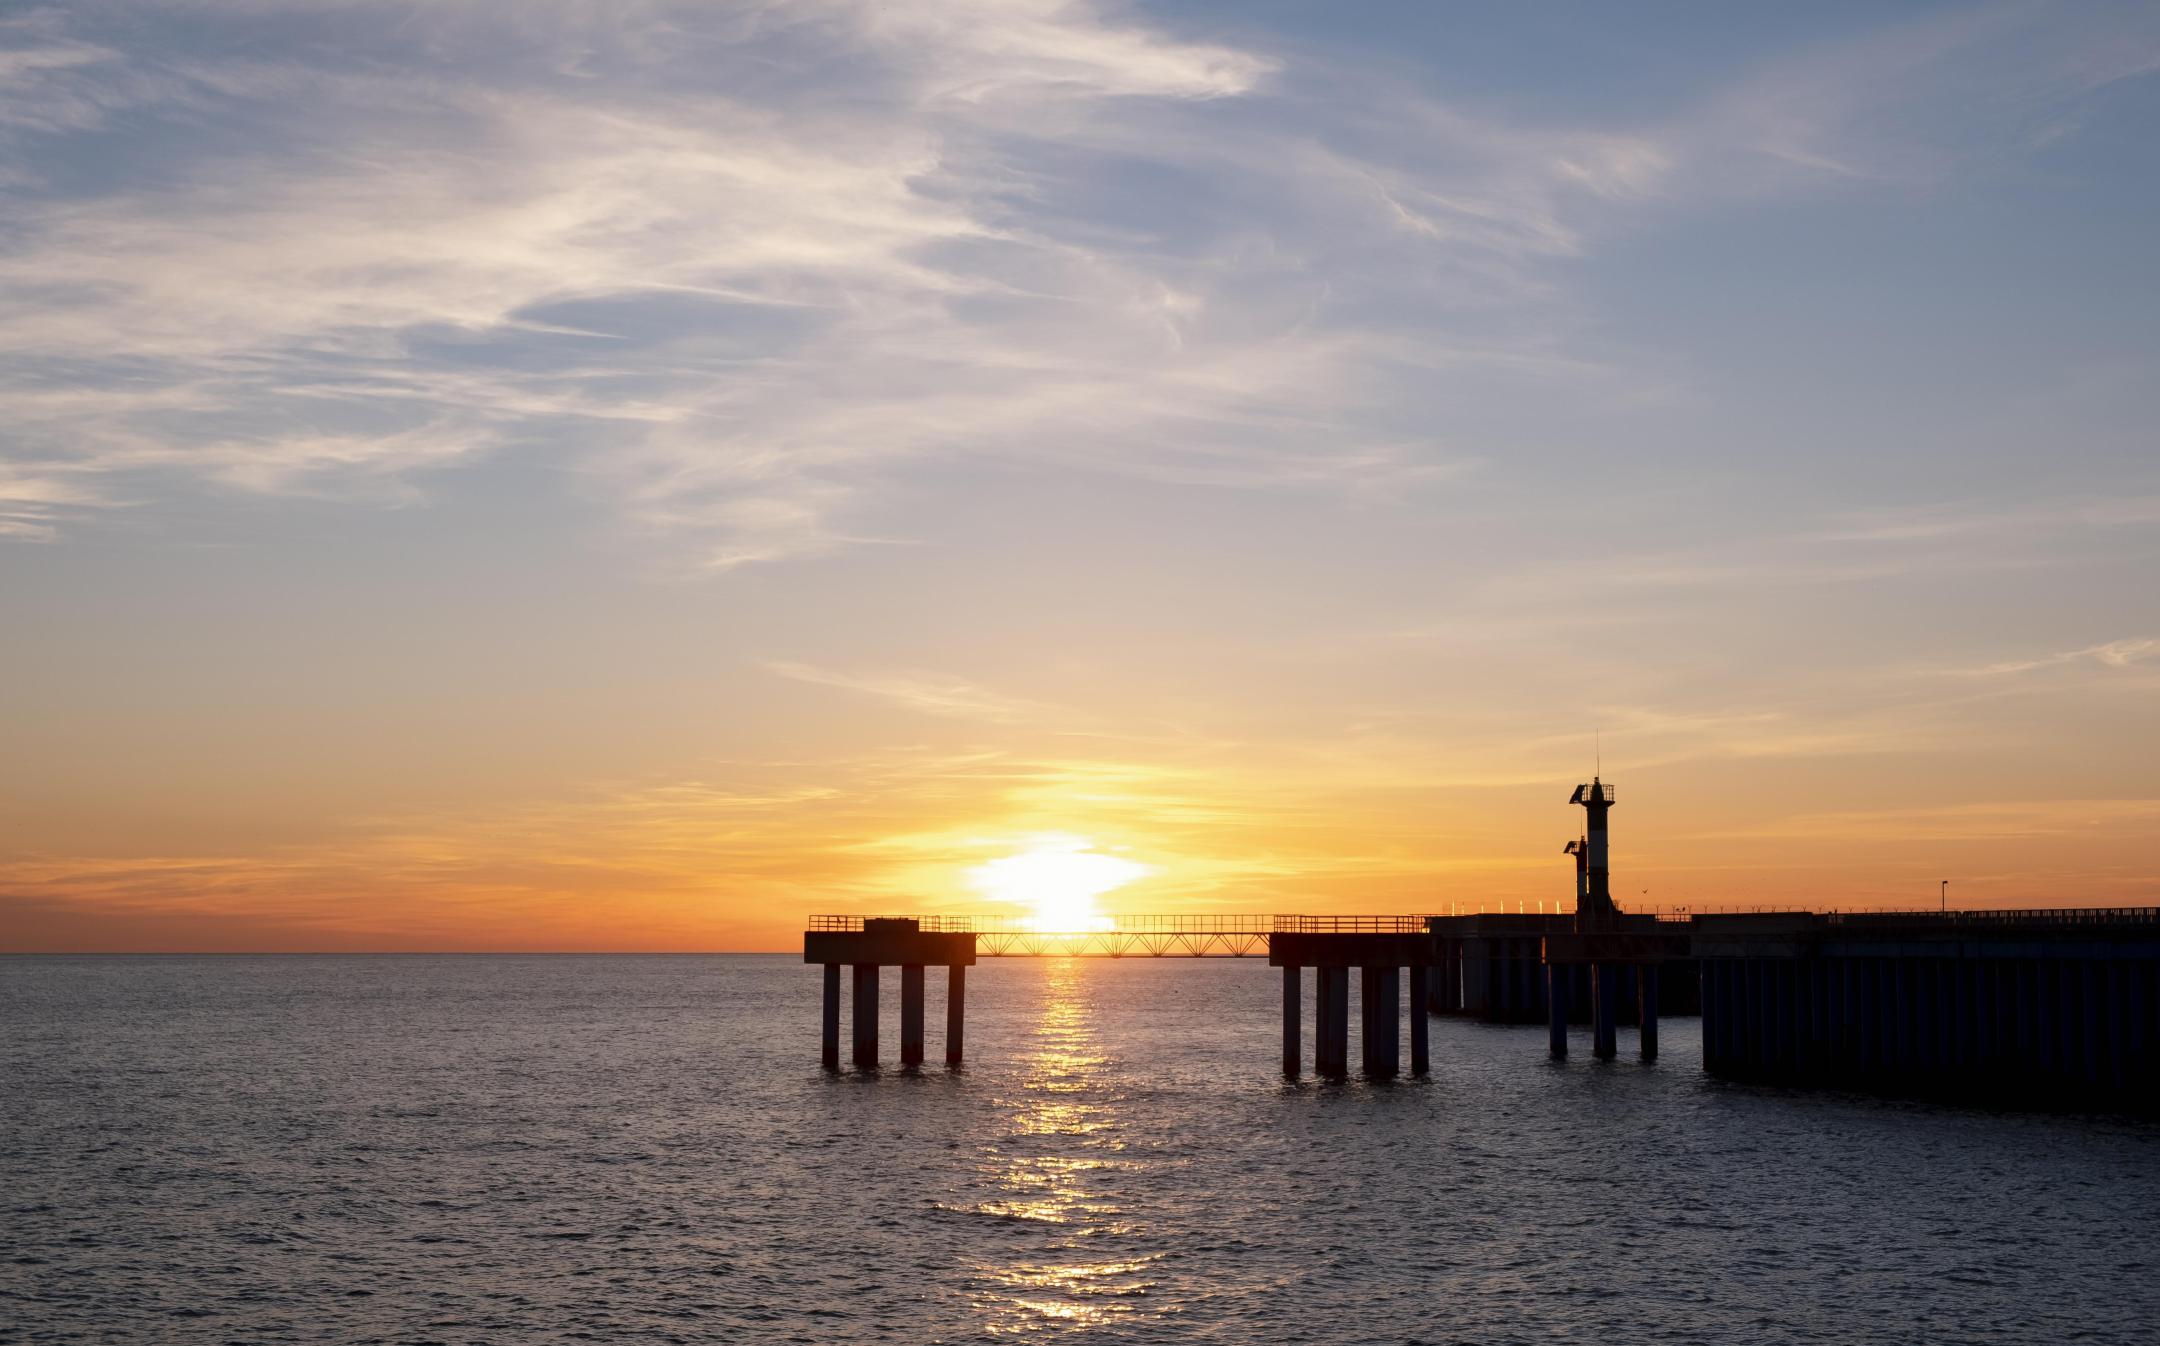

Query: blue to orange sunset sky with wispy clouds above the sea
left=0, top=0, right=2160, bottom=951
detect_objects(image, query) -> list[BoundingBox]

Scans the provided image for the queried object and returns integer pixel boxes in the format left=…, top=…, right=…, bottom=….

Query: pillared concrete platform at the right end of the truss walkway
left=1268, top=916, right=1432, bottom=1080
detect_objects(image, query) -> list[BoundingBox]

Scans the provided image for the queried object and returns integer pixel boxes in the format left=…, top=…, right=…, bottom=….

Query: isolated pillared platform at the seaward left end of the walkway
left=804, top=916, right=974, bottom=1069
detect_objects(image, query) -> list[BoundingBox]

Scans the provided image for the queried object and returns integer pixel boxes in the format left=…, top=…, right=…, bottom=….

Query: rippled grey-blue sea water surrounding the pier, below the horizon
left=0, top=957, right=2160, bottom=1344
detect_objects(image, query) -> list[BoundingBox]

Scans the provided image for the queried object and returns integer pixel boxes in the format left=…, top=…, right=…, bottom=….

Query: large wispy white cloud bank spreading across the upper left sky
left=0, top=0, right=2147, bottom=570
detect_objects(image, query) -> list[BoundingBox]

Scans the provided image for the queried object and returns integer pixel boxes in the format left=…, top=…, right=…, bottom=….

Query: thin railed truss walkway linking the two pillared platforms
left=810, top=916, right=1426, bottom=957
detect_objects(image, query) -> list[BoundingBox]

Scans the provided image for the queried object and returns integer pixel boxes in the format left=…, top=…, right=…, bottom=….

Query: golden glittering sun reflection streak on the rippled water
left=976, top=959, right=1156, bottom=1335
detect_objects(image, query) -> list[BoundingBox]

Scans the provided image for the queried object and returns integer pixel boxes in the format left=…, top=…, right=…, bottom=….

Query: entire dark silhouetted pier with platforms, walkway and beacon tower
left=804, top=778, right=2160, bottom=1113
